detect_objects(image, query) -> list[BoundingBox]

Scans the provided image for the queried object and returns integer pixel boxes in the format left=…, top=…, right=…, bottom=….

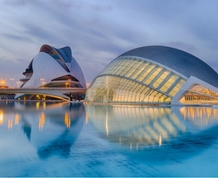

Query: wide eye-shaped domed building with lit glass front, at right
left=85, top=46, right=218, bottom=105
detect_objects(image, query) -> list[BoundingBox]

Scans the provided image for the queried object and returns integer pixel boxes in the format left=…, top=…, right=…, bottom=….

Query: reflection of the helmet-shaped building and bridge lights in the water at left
left=0, top=102, right=84, bottom=159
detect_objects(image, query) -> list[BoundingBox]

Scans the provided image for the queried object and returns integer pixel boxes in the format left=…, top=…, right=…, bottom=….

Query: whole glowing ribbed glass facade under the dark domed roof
left=86, top=56, right=186, bottom=104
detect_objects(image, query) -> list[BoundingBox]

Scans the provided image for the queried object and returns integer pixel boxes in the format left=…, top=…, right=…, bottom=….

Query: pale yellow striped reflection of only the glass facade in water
left=86, top=106, right=186, bottom=149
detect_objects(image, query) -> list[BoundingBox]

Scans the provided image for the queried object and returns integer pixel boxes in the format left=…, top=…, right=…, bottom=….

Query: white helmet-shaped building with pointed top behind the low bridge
left=16, top=44, right=86, bottom=100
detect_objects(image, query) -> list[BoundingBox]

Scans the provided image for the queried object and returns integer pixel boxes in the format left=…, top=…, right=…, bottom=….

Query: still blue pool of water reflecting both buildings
left=0, top=102, right=218, bottom=177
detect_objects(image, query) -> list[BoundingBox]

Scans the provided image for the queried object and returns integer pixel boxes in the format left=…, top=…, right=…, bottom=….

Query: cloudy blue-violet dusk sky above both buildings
left=0, top=0, right=218, bottom=86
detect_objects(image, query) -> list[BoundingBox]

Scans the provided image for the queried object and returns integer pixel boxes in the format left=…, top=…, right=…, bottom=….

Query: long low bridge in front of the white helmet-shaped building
left=0, top=87, right=86, bottom=99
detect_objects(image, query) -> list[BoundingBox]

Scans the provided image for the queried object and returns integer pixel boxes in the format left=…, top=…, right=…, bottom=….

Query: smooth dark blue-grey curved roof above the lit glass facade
left=119, top=46, right=218, bottom=87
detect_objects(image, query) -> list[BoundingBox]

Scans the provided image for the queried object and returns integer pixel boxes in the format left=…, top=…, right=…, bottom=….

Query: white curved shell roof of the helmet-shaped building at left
left=22, top=44, right=86, bottom=88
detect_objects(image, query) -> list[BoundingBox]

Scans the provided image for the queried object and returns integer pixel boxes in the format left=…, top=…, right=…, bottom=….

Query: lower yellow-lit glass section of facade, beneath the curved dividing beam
left=86, top=76, right=171, bottom=103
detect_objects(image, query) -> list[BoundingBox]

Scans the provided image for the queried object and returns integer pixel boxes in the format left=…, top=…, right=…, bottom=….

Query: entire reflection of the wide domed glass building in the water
left=86, top=106, right=218, bottom=155
